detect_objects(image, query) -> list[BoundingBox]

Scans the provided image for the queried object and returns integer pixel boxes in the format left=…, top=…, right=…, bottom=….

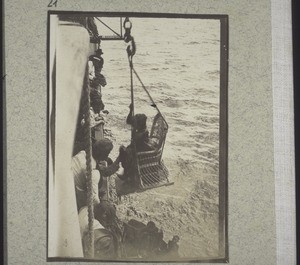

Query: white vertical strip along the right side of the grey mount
left=272, top=0, right=296, bottom=265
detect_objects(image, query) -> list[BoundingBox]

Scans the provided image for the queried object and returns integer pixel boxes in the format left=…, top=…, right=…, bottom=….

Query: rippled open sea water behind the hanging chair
left=100, top=18, right=220, bottom=259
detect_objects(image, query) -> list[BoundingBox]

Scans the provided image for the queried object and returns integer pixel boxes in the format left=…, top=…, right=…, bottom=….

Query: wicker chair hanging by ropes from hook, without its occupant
left=124, top=18, right=173, bottom=191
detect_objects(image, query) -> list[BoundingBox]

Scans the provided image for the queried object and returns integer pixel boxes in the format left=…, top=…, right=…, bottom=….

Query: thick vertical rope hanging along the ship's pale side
left=83, top=65, right=94, bottom=258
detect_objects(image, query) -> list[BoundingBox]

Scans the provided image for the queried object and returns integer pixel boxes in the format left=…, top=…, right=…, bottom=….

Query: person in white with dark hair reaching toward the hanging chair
left=72, top=139, right=119, bottom=210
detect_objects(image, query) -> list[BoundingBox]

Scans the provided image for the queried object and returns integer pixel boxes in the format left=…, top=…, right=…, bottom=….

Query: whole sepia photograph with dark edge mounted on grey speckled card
left=46, top=10, right=229, bottom=262
